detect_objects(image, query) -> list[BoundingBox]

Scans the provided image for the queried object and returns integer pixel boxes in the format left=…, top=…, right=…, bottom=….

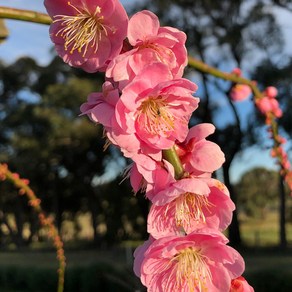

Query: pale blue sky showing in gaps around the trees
left=0, top=0, right=292, bottom=181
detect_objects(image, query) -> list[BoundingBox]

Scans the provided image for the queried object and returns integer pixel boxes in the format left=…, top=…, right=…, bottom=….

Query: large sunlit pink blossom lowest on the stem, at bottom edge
left=134, top=228, right=244, bottom=292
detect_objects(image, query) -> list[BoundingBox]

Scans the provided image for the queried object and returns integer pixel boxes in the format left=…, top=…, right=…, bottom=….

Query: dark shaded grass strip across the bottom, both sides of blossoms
left=0, top=248, right=292, bottom=292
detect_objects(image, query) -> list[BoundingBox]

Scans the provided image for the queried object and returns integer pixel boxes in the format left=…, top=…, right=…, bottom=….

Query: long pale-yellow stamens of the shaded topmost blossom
left=53, top=2, right=116, bottom=57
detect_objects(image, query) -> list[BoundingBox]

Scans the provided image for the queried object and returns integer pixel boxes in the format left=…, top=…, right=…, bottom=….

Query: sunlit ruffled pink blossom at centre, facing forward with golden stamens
left=116, top=63, right=199, bottom=153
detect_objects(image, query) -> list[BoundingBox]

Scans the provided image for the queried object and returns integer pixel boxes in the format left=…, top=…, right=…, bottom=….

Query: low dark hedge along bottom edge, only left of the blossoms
left=0, top=263, right=143, bottom=292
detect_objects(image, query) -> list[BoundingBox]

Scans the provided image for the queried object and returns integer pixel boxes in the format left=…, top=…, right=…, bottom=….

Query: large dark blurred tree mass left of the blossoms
left=0, top=58, right=145, bottom=245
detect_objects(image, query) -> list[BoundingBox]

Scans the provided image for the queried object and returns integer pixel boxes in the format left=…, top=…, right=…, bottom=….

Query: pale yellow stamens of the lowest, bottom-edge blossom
left=172, top=247, right=212, bottom=292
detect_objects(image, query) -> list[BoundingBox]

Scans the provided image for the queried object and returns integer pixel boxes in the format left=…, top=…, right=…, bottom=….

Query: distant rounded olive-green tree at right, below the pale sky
left=235, top=167, right=279, bottom=219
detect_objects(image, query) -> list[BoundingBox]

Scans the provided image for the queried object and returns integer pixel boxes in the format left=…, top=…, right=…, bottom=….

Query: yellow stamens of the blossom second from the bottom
left=175, top=193, right=211, bottom=228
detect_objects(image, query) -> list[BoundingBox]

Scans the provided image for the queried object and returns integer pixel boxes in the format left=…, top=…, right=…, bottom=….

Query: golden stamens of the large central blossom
left=137, top=96, right=174, bottom=135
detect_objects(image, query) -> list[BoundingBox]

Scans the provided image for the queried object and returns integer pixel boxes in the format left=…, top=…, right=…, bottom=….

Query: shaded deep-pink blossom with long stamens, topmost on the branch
left=44, top=0, right=128, bottom=72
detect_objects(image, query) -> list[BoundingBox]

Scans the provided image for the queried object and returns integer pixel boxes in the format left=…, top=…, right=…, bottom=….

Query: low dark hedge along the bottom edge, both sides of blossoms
left=0, top=263, right=292, bottom=292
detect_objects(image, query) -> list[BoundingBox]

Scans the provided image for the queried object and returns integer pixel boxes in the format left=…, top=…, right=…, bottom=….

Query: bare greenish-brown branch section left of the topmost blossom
left=0, top=6, right=52, bottom=24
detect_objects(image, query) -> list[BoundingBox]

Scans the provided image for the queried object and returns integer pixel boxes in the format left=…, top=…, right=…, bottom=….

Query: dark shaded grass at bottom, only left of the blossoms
left=0, top=249, right=142, bottom=292
